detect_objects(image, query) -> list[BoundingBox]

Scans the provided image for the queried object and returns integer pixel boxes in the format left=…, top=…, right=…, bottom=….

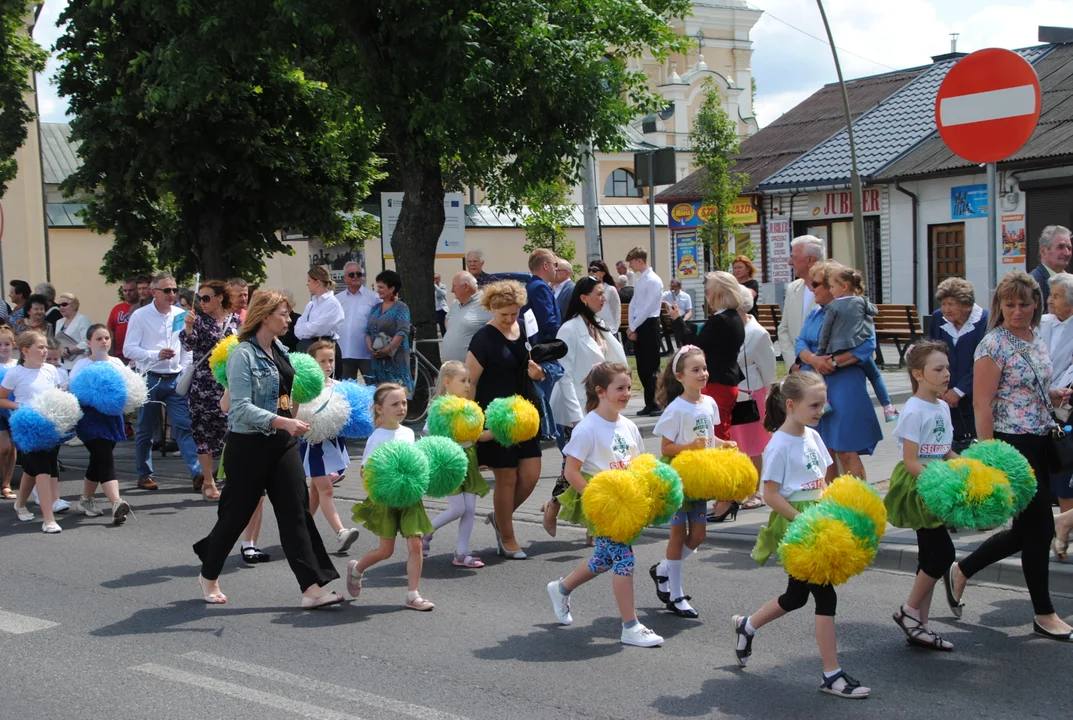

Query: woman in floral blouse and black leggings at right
left=944, top=270, right=1073, bottom=642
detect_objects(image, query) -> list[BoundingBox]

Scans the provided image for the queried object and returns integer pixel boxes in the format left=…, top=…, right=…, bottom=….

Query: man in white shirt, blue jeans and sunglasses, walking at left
left=123, top=275, right=201, bottom=490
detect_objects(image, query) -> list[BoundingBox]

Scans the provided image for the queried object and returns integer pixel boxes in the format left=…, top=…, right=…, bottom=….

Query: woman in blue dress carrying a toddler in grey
left=794, top=261, right=883, bottom=480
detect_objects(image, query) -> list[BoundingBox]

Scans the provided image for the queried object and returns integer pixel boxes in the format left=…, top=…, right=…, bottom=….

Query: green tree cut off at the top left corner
left=0, top=0, right=48, bottom=197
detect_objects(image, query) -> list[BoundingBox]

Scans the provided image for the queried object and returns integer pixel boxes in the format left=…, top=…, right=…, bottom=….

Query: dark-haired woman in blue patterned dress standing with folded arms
left=365, top=270, right=413, bottom=394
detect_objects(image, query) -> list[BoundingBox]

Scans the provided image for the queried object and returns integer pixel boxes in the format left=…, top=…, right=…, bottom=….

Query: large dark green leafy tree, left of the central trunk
left=57, top=0, right=378, bottom=281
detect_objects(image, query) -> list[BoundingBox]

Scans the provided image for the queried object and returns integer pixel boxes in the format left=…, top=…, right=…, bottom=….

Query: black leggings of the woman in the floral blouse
left=957, top=432, right=1055, bottom=615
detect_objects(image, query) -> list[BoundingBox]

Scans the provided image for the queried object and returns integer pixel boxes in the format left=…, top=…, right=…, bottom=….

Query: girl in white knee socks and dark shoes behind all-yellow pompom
left=648, top=346, right=737, bottom=618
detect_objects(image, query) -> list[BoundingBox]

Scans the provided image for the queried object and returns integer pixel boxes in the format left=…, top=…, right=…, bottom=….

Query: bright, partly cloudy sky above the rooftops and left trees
left=33, top=0, right=1073, bottom=127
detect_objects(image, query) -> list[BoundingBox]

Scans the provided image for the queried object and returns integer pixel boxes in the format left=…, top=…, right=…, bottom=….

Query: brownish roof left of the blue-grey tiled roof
left=656, top=68, right=926, bottom=203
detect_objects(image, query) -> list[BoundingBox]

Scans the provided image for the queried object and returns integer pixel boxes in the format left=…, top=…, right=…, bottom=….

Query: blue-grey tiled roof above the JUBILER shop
left=760, top=45, right=1054, bottom=192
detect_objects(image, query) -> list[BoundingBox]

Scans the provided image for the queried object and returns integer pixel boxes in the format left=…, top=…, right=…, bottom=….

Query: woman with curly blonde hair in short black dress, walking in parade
left=466, top=280, right=545, bottom=560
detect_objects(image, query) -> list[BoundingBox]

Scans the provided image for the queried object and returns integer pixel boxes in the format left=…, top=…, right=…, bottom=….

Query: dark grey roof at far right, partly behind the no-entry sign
left=869, top=45, right=1073, bottom=182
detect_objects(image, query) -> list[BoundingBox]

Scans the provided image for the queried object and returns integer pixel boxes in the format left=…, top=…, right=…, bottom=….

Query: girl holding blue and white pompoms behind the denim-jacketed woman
left=298, top=340, right=357, bottom=553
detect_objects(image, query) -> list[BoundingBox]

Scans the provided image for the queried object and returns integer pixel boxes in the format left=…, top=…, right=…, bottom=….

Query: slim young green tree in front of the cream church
left=689, top=79, right=752, bottom=270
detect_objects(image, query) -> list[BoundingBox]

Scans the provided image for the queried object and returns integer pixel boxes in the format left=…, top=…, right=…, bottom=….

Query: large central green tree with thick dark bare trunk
left=302, top=0, right=692, bottom=337
